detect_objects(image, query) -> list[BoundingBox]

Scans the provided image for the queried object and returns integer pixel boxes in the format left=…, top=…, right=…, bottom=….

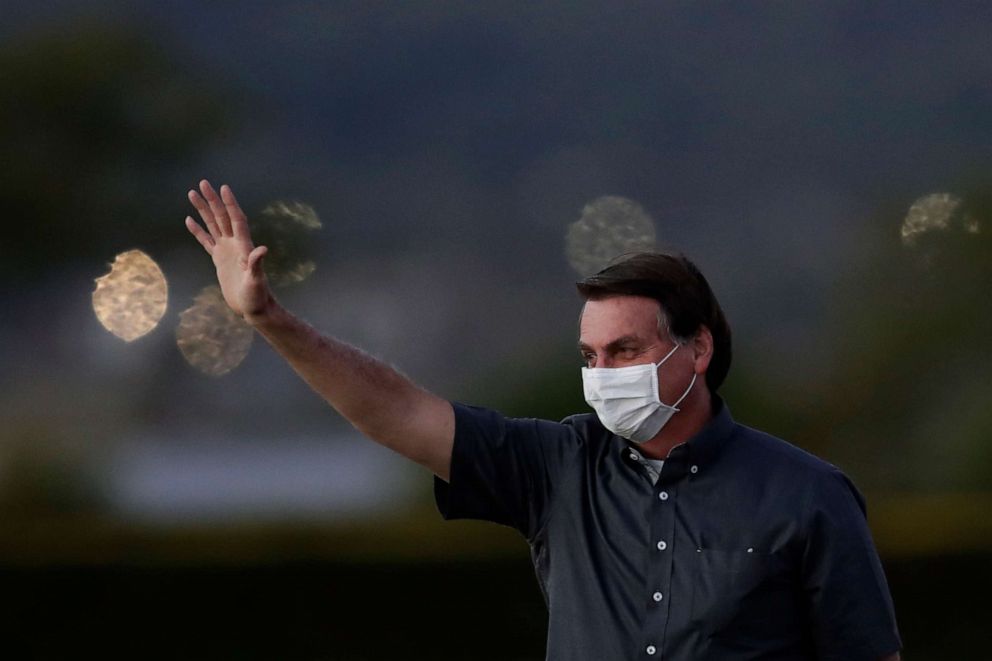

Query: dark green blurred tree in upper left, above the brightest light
left=0, top=22, right=232, bottom=282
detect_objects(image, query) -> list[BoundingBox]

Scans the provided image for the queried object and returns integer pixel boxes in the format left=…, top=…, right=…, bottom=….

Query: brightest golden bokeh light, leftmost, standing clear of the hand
left=93, top=250, right=169, bottom=342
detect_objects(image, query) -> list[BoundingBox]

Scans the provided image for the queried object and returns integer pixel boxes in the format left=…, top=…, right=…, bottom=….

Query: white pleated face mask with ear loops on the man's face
left=582, top=344, right=696, bottom=443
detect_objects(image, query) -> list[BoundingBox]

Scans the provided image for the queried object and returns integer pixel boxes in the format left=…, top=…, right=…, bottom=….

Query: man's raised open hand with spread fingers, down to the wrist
left=186, top=179, right=272, bottom=318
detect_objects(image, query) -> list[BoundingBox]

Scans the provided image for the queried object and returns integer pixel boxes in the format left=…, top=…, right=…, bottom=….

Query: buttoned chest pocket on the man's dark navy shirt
left=691, top=549, right=795, bottom=637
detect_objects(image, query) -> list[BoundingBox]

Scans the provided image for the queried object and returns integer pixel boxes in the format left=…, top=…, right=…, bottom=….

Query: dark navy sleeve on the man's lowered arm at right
left=802, top=470, right=902, bottom=661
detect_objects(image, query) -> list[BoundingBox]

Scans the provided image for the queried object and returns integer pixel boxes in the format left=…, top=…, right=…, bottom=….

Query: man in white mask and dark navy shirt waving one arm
left=186, top=181, right=901, bottom=661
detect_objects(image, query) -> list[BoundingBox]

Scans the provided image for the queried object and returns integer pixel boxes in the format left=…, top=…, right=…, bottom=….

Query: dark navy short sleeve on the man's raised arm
left=434, top=403, right=581, bottom=540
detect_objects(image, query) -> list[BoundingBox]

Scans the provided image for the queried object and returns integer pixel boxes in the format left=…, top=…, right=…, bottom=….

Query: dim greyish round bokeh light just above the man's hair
left=565, top=195, right=655, bottom=277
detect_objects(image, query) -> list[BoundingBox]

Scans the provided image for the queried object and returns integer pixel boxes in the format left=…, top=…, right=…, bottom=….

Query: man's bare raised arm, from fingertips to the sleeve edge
left=186, top=180, right=455, bottom=480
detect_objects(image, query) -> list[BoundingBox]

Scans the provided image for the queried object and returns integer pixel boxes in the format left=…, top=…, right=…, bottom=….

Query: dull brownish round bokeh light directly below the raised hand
left=176, top=285, right=254, bottom=376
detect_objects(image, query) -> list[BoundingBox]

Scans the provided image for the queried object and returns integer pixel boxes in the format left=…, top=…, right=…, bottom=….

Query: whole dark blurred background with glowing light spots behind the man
left=0, top=0, right=992, bottom=660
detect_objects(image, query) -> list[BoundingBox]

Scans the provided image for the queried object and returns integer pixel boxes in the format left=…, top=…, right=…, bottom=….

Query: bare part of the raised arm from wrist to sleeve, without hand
left=245, top=300, right=455, bottom=480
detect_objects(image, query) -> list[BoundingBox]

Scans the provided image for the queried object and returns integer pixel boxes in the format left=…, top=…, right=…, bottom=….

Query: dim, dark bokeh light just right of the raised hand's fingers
left=252, top=200, right=321, bottom=287
